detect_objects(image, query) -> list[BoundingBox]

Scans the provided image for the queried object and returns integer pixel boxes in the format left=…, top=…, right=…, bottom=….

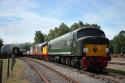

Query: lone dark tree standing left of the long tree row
left=34, top=31, right=44, bottom=44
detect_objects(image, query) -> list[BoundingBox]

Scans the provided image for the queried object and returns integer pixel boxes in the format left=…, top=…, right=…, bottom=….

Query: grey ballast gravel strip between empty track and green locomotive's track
left=39, top=60, right=105, bottom=83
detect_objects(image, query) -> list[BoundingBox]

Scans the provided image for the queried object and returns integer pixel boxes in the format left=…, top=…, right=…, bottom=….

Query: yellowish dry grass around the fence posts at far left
left=3, top=59, right=29, bottom=83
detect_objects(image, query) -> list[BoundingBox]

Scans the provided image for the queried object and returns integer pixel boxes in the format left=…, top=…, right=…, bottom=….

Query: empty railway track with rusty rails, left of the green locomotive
left=21, top=58, right=79, bottom=83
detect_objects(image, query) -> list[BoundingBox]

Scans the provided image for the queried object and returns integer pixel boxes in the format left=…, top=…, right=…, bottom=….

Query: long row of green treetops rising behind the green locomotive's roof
left=44, top=21, right=100, bottom=41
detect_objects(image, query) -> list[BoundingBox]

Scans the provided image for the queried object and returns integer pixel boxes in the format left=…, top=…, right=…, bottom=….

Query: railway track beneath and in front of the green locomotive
left=43, top=59, right=125, bottom=83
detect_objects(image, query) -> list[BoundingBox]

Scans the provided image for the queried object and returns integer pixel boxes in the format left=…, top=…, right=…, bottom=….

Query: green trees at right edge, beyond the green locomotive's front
left=110, top=31, right=125, bottom=53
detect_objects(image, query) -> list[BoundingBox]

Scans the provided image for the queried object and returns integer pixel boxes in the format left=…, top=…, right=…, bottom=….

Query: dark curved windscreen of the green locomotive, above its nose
left=77, top=28, right=105, bottom=38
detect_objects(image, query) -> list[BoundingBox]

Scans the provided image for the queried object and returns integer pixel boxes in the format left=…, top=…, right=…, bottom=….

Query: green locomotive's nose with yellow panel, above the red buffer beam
left=81, top=36, right=109, bottom=56
